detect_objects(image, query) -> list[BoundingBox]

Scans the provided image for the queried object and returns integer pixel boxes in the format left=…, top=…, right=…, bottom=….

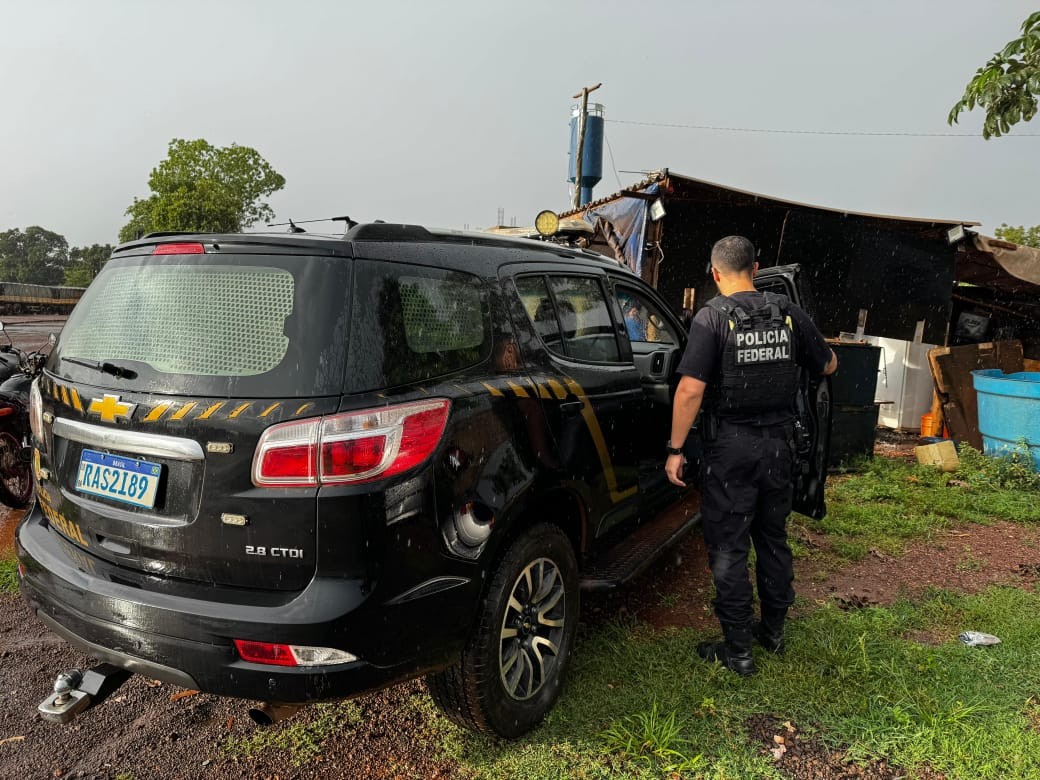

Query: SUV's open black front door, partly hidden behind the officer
left=755, top=264, right=831, bottom=520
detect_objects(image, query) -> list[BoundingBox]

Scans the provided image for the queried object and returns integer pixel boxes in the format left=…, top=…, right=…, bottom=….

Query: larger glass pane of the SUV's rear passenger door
left=549, top=277, right=621, bottom=363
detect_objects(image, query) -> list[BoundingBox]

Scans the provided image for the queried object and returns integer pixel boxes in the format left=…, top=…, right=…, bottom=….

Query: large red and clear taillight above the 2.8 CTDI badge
left=253, top=398, right=451, bottom=488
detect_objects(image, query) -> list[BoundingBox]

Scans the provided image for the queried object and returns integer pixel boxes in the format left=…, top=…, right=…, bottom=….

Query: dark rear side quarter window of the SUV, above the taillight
left=346, top=260, right=491, bottom=392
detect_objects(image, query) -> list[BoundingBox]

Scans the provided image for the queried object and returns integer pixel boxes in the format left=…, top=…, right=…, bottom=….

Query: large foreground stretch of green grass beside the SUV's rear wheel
left=432, top=588, right=1040, bottom=779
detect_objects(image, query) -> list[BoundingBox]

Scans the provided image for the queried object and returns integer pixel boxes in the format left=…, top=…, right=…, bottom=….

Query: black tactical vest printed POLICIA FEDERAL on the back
left=707, top=292, right=798, bottom=418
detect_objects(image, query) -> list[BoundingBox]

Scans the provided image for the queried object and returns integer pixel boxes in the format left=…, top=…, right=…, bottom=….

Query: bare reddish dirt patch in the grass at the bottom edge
left=747, top=716, right=945, bottom=780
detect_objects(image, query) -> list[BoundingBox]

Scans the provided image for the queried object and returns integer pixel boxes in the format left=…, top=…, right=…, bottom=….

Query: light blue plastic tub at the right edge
left=971, top=368, right=1040, bottom=471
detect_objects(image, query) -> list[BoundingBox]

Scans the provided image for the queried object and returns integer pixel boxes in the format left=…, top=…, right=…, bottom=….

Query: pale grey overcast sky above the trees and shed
left=0, top=0, right=1040, bottom=244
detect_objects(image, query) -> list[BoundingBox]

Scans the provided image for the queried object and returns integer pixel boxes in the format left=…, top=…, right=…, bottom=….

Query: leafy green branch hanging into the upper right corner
left=946, top=11, right=1040, bottom=140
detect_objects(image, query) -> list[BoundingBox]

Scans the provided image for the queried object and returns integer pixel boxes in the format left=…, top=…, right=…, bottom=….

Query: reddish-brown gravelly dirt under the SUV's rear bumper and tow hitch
left=0, top=595, right=464, bottom=780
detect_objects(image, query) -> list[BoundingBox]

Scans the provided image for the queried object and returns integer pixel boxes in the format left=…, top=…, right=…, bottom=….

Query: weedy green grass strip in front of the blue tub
left=794, top=447, right=1040, bottom=561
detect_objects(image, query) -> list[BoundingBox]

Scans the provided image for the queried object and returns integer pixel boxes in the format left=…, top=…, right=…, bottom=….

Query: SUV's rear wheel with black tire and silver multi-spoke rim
left=426, top=523, right=579, bottom=738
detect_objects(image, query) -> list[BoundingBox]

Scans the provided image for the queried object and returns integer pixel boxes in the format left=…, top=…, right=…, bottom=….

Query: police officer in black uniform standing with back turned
left=665, top=236, right=837, bottom=676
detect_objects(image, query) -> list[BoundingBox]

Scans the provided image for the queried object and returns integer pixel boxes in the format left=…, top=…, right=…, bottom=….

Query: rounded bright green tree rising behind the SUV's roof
left=120, top=138, right=285, bottom=241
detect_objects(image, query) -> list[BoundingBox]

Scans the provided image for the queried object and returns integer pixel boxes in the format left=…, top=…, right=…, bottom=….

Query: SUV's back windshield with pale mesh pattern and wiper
left=51, top=255, right=349, bottom=397
